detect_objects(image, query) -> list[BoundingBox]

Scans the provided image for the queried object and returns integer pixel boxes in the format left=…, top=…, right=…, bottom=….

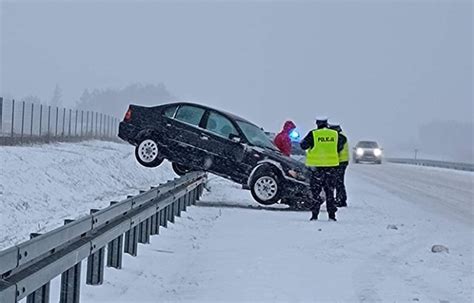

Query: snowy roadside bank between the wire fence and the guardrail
left=0, top=141, right=175, bottom=249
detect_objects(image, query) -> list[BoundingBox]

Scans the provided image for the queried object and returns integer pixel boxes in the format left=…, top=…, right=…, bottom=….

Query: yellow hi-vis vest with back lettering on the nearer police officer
left=306, top=128, right=339, bottom=167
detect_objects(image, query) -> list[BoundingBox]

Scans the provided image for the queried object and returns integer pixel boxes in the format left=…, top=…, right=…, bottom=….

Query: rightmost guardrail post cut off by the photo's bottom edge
left=59, top=220, right=82, bottom=303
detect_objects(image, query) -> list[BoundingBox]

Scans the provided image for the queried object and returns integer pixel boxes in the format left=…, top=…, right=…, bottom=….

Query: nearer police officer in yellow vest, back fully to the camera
left=300, top=117, right=346, bottom=221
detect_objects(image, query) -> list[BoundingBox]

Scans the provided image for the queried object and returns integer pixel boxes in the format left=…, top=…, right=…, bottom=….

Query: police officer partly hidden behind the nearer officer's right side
left=329, top=123, right=349, bottom=207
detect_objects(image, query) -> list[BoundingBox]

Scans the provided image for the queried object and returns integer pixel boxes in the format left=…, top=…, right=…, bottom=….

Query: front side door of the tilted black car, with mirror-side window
left=201, top=110, right=244, bottom=182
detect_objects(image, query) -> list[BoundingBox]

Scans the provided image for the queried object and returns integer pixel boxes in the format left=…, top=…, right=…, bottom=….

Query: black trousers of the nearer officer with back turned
left=310, top=167, right=338, bottom=215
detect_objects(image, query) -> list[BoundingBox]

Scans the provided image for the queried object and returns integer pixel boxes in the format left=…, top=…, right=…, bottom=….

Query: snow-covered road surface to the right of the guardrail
left=78, top=165, right=473, bottom=302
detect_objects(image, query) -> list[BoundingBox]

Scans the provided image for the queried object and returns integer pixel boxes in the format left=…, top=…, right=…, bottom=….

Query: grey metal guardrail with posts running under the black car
left=0, top=172, right=207, bottom=303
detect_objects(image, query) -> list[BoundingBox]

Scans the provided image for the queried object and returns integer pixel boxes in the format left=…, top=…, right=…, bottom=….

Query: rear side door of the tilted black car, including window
left=168, top=104, right=206, bottom=169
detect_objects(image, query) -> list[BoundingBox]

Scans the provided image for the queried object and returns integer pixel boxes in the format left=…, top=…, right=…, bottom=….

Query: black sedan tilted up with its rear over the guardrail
left=119, top=103, right=309, bottom=205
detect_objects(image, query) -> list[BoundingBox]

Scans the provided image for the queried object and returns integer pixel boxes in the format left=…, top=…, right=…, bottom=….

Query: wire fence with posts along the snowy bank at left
left=0, top=97, right=119, bottom=145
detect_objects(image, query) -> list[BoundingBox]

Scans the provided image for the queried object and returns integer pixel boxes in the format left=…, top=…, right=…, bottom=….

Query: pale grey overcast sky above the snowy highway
left=0, top=1, right=473, bottom=154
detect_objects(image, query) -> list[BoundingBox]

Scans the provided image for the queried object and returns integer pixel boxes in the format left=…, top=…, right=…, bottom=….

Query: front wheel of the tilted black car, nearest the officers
left=250, top=167, right=282, bottom=205
